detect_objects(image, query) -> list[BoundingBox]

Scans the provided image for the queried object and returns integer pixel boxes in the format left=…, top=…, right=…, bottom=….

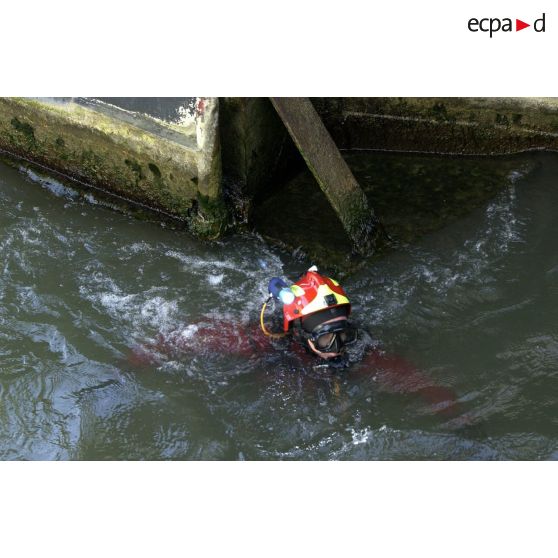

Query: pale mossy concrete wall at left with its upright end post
left=0, top=98, right=227, bottom=237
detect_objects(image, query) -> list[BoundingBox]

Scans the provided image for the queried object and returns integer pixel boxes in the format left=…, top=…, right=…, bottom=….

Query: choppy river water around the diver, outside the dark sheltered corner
left=0, top=153, right=558, bottom=460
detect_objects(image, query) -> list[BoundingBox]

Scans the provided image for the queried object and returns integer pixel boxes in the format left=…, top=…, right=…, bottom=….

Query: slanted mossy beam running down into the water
left=271, top=97, right=380, bottom=254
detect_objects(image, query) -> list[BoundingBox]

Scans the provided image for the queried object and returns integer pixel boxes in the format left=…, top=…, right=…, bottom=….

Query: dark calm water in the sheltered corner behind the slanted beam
left=256, top=151, right=537, bottom=270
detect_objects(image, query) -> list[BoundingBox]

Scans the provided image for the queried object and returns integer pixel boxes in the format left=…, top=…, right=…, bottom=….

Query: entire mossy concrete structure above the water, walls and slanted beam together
left=0, top=97, right=558, bottom=260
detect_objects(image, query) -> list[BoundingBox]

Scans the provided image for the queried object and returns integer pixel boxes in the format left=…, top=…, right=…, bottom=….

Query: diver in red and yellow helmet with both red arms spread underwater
left=131, top=266, right=464, bottom=416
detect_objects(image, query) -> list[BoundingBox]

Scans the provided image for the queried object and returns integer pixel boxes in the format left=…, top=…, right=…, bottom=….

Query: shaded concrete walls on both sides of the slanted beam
left=219, top=97, right=558, bottom=238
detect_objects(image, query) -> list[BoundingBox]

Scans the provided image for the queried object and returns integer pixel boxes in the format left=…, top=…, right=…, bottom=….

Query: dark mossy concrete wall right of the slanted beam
left=312, top=97, right=558, bottom=155
